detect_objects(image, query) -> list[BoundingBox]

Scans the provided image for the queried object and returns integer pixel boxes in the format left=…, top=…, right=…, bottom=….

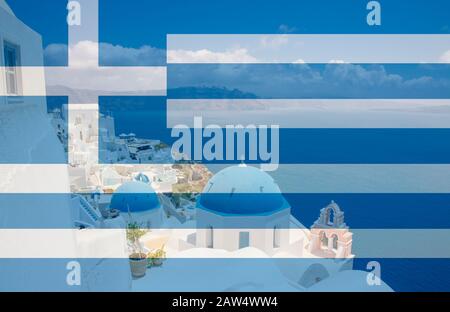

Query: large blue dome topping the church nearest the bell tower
left=197, top=165, right=289, bottom=215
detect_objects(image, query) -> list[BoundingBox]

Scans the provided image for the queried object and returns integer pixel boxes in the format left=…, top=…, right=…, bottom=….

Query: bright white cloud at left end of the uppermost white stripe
left=167, top=48, right=257, bottom=63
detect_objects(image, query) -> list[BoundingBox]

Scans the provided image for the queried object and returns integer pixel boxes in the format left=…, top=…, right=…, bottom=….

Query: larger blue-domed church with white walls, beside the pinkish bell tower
left=196, top=165, right=291, bottom=254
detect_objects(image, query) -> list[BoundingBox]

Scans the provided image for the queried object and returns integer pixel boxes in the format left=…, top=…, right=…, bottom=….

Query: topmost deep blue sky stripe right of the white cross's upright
left=100, top=0, right=450, bottom=48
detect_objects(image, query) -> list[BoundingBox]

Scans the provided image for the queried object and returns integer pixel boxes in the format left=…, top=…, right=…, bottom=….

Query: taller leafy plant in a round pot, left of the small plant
left=127, top=222, right=147, bottom=278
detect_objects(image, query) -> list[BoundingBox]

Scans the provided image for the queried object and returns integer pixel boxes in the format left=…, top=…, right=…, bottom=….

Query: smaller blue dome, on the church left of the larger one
left=110, top=181, right=161, bottom=212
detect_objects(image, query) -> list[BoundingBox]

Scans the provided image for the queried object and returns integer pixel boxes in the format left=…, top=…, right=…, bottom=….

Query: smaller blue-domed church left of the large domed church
left=110, top=180, right=162, bottom=228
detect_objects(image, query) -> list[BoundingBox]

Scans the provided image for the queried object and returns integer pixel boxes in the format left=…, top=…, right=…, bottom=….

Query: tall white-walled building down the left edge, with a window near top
left=0, top=0, right=131, bottom=291
